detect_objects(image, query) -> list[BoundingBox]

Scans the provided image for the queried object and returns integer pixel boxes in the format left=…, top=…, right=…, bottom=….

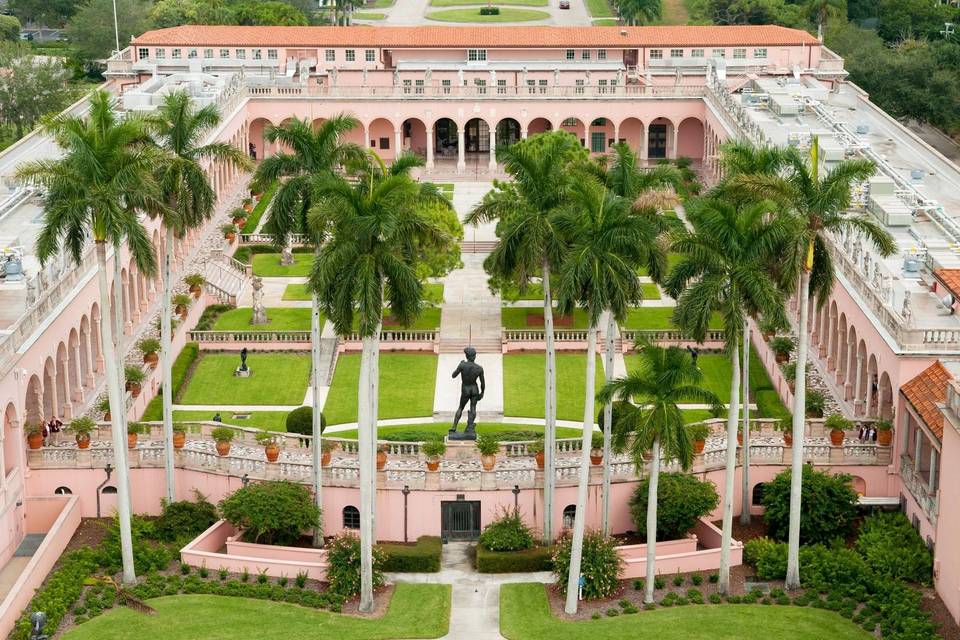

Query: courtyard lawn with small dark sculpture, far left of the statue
left=177, top=351, right=310, bottom=405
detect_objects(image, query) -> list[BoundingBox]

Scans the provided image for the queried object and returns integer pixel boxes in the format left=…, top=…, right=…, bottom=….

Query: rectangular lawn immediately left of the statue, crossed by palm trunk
left=326, top=353, right=437, bottom=424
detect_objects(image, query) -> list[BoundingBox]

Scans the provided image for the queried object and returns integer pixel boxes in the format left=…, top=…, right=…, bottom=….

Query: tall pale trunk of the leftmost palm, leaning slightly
left=96, top=240, right=137, bottom=584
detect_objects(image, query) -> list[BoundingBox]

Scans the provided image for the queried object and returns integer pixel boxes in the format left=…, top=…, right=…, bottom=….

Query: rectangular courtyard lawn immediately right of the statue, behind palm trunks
left=503, top=353, right=603, bottom=421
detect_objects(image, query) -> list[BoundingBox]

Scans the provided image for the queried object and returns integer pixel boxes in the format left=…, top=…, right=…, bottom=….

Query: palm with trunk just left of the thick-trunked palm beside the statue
left=251, top=114, right=363, bottom=547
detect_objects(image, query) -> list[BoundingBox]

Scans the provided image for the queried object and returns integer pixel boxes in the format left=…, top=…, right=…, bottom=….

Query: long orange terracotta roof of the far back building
left=133, top=25, right=819, bottom=48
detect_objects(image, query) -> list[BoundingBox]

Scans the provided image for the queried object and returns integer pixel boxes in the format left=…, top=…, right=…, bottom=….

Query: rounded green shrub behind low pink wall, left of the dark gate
left=220, top=481, right=320, bottom=545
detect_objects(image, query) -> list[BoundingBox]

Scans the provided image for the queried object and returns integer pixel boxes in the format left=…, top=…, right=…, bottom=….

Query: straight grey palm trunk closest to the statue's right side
left=541, top=260, right=557, bottom=545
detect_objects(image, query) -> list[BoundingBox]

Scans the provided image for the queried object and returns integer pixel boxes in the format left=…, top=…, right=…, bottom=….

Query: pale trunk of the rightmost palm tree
left=786, top=269, right=810, bottom=589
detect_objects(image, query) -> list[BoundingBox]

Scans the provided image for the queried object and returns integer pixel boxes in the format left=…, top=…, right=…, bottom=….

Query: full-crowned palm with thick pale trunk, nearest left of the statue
left=309, top=151, right=452, bottom=611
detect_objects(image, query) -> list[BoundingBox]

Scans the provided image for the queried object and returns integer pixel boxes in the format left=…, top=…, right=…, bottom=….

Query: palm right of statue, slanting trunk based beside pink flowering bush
left=556, top=175, right=664, bottom=614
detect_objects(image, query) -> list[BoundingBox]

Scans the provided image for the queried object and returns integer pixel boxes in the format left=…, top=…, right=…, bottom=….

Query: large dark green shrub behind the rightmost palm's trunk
left=763, top=465, right=857, bottom=544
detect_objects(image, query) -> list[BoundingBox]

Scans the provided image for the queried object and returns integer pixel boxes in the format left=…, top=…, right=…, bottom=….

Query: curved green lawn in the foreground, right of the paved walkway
left=500, top=583, right=874, bottom=640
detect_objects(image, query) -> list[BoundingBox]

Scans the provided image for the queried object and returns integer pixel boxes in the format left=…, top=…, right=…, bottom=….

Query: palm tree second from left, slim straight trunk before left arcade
left=148, top=91, right=250, bottom=502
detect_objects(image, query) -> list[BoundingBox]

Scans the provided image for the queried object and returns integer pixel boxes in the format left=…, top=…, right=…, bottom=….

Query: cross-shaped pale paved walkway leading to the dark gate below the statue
left=386, top=542, right=554, bottom=640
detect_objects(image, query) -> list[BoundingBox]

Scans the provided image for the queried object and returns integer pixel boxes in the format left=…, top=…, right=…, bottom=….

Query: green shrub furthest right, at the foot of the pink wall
left=856, top=513, right=933, bottom=584
